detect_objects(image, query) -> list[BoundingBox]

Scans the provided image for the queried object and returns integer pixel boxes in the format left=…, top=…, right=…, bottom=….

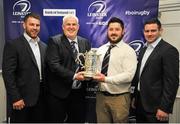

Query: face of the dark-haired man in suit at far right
left=144, top=23, right=162, bottom=43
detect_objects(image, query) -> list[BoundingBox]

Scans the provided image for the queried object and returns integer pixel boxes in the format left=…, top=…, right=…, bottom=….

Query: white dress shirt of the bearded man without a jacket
left=97, top=40, right=137, bottom=94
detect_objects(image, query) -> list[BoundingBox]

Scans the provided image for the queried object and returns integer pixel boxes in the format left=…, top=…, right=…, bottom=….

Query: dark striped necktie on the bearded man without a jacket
left=101, top=45, right=115, bottom=76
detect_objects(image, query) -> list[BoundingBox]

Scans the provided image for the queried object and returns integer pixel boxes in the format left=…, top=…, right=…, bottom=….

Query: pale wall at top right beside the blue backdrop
left=159, top=0, right=180, bottom=51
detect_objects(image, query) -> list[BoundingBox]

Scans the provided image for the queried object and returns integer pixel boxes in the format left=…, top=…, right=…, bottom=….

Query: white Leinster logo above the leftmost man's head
left=13, top=0, right=31, bottom=16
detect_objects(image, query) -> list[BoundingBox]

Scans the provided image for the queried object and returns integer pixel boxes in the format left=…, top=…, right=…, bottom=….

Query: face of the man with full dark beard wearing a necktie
left=108, top=22, right=124, bottom=43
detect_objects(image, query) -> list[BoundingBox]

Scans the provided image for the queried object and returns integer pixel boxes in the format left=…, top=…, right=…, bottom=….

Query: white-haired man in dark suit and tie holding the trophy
left=46, top=15, right=90, bottom=123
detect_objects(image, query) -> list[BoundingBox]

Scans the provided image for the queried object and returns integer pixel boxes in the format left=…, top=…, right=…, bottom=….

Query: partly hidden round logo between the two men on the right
left=129, top=40, right=144, bottom=55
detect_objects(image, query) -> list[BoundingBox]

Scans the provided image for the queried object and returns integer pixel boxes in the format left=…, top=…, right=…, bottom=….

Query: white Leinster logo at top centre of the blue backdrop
left=87, top=0, right=107, bottom=18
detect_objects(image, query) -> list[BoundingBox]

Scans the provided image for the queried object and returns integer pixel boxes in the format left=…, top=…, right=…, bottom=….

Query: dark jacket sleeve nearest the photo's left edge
left=2, top=43, right=21, bottom=102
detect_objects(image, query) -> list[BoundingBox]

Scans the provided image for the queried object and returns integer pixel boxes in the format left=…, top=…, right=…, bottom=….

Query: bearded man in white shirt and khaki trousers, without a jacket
left=94, top=17, right=137, bottom=123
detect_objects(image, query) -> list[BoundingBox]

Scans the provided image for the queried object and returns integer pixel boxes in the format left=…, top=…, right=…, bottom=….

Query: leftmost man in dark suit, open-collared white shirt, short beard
left=2, top=13, right=46, bottom=123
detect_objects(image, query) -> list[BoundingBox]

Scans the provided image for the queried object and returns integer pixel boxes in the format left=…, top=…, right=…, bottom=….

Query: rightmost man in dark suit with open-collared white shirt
left=133, top=19, right=179, bottom=123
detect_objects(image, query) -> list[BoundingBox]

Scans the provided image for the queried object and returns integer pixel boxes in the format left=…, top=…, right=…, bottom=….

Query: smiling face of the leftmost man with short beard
left=23, top=17, right=40, bottom=39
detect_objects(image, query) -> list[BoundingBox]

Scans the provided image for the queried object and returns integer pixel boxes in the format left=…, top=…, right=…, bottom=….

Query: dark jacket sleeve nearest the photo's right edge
left=160, top=47, right=179, bottom=113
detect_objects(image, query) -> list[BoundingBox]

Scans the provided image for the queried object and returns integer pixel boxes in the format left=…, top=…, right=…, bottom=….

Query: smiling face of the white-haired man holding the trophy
left=62, top=17, right=79, bottom=40
